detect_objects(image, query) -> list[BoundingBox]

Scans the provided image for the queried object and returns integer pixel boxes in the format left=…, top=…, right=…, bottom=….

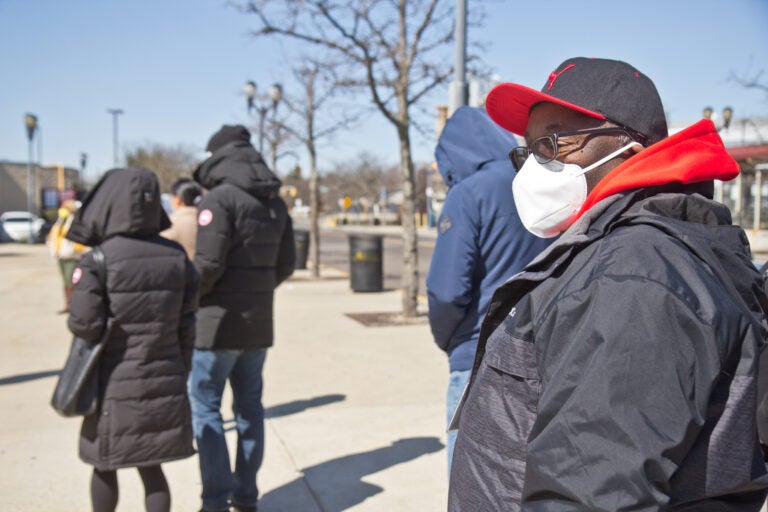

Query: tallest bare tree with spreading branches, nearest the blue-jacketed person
left=242, top=0, right=462, bottom=317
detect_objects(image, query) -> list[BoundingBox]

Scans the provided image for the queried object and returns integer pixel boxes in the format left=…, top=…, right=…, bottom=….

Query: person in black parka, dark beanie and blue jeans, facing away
left=189, top=125, right=295, bottom=511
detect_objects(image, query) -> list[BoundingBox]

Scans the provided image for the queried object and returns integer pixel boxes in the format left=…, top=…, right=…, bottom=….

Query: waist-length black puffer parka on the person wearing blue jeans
left=195, top=142, right=296, bottom=349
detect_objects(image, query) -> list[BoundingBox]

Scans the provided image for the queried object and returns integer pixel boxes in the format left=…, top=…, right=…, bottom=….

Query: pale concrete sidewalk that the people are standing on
left=0, top=244, right=448, bottom=512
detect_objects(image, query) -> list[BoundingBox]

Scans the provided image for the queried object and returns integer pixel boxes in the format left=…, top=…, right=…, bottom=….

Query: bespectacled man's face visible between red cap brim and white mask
left=525, top=103, right=634, bottom=192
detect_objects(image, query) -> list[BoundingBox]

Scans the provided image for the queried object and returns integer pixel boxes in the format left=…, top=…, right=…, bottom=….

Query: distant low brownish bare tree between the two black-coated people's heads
left=125, top=142, right=199, bottom=192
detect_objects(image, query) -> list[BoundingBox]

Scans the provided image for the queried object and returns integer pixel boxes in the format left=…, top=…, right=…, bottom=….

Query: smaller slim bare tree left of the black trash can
left=285, top=58, right=356, bottom=277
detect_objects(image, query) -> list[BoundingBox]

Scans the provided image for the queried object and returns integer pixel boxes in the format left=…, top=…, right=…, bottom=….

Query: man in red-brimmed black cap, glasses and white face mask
left=449, top=58, right=768, bottom=512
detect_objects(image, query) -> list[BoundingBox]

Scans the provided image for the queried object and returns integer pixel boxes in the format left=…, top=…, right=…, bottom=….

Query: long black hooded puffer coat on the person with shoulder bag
left=67, top=169, right=198, bottom=470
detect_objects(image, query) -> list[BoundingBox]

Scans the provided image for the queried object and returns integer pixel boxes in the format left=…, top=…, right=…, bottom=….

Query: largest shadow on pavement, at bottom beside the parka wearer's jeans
left=259, top=437, right=443, bottom=512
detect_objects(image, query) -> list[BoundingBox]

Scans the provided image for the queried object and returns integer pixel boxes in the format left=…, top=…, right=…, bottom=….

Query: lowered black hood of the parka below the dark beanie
left=194, top=141, right=282, bottom=199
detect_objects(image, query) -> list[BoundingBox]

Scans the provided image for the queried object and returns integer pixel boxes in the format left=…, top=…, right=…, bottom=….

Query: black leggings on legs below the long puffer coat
left=91, top=465, right=171, bottom=512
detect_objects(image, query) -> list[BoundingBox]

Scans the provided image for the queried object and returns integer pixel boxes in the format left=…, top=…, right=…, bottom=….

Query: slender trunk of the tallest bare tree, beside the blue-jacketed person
left=397, top=120, right=419, bottom=318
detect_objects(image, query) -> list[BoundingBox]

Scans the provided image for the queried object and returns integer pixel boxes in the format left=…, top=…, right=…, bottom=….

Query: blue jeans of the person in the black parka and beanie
left=187, top=349, right=267, bottom=510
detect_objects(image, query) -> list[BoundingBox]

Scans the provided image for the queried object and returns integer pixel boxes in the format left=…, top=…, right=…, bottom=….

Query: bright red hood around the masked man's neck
left=576, top=119, right=739, bottom=218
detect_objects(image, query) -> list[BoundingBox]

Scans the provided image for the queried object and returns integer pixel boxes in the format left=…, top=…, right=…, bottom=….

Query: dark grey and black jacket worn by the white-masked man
left=449, top=182, right=768, bottom=512
